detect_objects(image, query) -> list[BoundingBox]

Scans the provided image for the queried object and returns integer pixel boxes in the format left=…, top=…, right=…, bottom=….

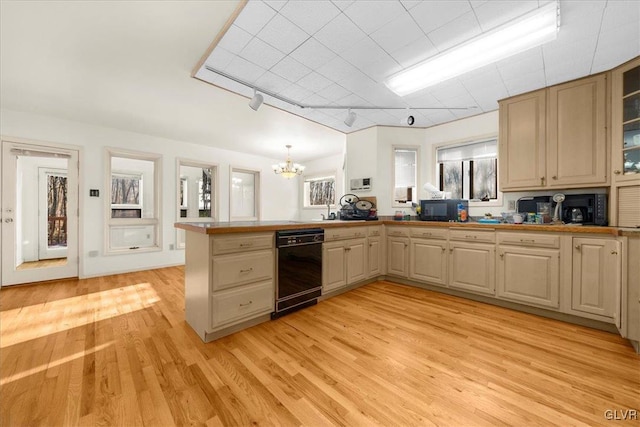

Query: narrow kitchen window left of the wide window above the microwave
left=393, top=147, right=418, bottom=207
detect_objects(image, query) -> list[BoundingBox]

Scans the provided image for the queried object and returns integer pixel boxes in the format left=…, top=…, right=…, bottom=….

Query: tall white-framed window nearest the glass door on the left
left=105, top=149, right=162, bottom=254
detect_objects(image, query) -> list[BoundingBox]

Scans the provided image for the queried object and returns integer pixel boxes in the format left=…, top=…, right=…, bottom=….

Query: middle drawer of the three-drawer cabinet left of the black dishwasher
left=212, top=250, right=274, bottom=291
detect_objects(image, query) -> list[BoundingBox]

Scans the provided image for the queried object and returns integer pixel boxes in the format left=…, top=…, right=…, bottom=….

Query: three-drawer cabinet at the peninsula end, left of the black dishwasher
left=185, top=231, right=275, bottom=341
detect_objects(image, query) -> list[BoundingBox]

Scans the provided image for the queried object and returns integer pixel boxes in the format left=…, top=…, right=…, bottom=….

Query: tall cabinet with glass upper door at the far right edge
left=609, top=57, right=640, bottom=228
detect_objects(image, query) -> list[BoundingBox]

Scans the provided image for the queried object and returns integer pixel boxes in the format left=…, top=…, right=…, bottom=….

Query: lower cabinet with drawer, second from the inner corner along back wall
left=409, top=227, right=449, bottom=286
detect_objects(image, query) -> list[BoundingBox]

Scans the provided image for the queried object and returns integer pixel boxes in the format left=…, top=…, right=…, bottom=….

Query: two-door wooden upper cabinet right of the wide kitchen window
left=498, top=74, right=608, bottom=191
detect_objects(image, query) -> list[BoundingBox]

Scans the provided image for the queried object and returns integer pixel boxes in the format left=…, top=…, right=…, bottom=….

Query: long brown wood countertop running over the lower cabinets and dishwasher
left=174, top=220, right=640, bottom=236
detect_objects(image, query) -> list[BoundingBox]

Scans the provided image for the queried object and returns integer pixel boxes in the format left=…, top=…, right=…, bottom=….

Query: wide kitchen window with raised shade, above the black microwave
left=436, top=139, right=499, bottom=202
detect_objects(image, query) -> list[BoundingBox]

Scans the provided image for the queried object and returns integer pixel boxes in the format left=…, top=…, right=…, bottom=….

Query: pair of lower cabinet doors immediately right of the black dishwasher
left=322, top=239, right=369, bottom=293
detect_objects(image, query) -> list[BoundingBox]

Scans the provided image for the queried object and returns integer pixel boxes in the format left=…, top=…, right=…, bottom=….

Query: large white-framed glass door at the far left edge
left=0, top=141, right=78, bottom=286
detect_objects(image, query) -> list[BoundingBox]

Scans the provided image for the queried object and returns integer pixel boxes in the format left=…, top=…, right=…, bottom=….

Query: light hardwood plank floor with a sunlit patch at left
left=0, top=267, right=640, bottom=426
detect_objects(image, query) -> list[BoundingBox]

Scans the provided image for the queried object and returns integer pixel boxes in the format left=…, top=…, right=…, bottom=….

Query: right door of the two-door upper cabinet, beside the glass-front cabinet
left=547, top=74, right=608, bottom=187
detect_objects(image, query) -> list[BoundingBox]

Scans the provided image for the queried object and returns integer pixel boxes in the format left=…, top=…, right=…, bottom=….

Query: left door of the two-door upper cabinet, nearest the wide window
left=498, top=90, right=546, bottom=190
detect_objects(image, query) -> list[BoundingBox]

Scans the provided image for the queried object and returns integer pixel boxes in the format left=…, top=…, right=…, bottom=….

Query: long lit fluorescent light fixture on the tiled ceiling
left=385, top=2, right=560, bottom=96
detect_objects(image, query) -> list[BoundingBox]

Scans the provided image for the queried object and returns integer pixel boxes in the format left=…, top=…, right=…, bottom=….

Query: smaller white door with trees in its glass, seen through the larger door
left=38, top=168, right=69, bottom=261
